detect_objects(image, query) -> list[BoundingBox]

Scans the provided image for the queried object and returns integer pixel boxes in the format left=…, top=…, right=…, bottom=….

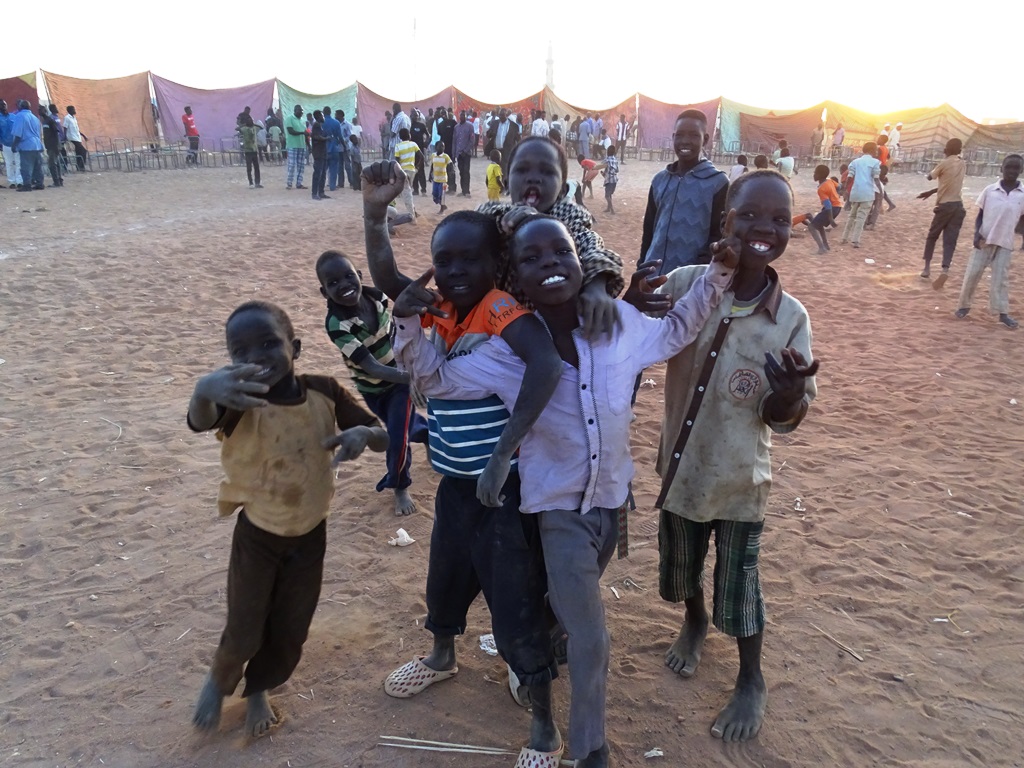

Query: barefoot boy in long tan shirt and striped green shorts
left=656, top=171, right=818, bottom=741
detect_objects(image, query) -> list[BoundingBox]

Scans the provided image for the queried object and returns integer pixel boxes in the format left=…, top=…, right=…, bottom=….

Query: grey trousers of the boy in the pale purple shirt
left=540, top=507, right=618, bottom=760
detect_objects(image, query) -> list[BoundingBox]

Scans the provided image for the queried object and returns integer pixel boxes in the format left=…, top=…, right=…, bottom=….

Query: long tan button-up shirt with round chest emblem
left=657, top=265, right=817, bottom=522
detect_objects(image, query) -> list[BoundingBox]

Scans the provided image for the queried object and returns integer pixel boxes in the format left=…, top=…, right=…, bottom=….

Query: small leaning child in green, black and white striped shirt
left=316, top=252, right=427, bottom=516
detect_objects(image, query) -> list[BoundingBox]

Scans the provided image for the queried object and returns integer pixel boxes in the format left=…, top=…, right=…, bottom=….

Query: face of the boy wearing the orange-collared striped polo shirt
left=430, top=221, right=495, bottom=315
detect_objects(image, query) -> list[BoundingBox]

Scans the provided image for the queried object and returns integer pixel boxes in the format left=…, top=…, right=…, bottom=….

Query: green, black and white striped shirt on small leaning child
left=325, top=286, right=395, bottom=394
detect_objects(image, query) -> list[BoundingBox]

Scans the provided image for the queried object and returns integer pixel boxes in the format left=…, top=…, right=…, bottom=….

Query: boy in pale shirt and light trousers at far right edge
left=956, top=155, right=1024, bottom=328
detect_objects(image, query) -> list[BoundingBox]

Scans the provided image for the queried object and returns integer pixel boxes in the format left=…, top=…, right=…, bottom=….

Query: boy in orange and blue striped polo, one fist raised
left=362, top=163, right=561, bottom=751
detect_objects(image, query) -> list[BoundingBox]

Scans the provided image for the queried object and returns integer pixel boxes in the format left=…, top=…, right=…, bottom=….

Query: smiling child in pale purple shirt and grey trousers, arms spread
left=395, top=215, right=736, bottom=768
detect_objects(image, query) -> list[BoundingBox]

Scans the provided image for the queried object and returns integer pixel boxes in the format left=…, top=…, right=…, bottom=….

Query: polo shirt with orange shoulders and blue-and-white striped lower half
left=422, top=289, right=529, bottom=477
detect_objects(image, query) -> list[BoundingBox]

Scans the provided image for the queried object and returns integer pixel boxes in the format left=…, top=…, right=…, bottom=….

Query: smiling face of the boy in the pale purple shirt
left=511, top=217, right=583, bottom=308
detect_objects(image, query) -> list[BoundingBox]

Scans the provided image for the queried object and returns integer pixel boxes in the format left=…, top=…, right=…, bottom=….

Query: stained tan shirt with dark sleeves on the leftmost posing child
left=209, top=376, right=377, bottom=537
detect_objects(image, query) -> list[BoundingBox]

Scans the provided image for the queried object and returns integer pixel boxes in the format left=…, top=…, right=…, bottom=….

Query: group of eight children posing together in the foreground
left=188, top=112, right=817, bottom=768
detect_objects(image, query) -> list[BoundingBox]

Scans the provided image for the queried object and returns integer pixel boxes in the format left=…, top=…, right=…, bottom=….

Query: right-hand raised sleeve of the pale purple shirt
left=631, top=264, right=735, bottom=368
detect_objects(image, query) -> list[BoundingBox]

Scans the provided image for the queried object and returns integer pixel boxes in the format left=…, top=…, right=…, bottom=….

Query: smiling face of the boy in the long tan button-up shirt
left=723, top=173, right=793, bottom=272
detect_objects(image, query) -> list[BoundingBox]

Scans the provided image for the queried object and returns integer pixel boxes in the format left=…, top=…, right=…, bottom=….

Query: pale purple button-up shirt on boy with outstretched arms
left=393, top=264, right=733, bottom=514
